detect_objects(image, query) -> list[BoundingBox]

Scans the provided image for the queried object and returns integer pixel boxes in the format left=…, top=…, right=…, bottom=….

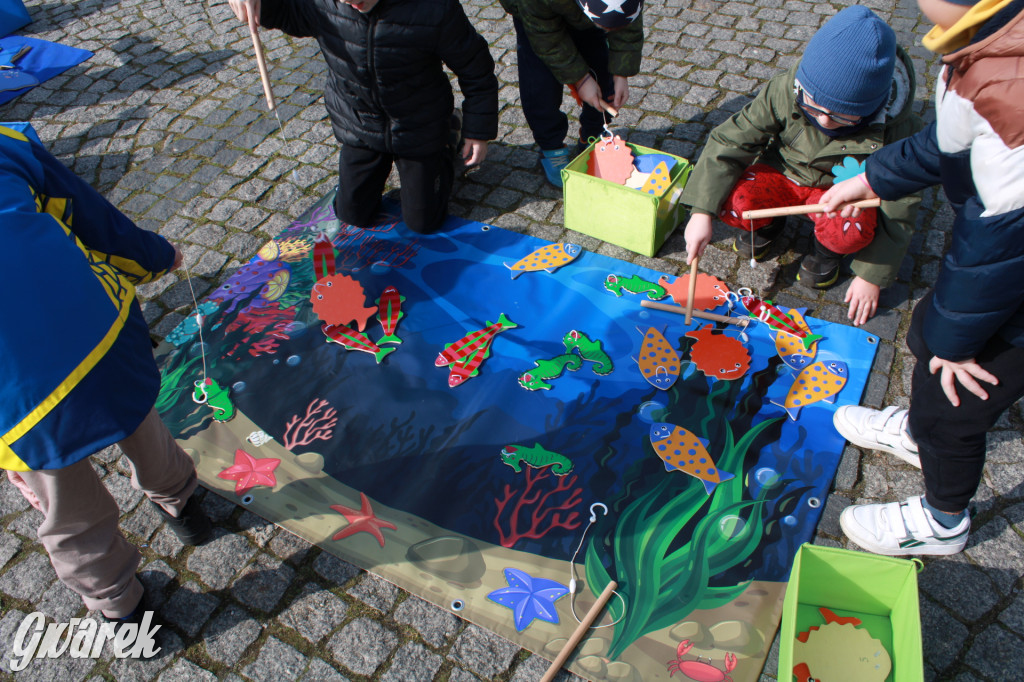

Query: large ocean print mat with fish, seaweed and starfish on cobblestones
left=158, top=195, right=878, bottom=681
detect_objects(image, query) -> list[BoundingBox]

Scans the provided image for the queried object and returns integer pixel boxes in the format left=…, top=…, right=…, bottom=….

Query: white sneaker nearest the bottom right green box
left=839, top=495, right=971, bottom=556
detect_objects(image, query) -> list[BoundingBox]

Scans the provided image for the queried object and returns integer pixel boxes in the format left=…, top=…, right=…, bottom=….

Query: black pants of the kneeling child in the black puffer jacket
left=334, top=144, right=455, bottom=235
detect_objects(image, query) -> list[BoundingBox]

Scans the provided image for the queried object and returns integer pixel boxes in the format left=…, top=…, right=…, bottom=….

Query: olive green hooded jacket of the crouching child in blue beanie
left=681, top=47, right=922, bottom=287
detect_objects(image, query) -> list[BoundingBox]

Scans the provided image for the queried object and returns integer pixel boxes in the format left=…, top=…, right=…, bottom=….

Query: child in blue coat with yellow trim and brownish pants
left=0, top=126, right=212, bottom=628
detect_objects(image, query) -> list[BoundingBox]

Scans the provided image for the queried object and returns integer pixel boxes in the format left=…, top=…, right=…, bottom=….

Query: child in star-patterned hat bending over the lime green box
left=501, top=0, right=643, bottom=187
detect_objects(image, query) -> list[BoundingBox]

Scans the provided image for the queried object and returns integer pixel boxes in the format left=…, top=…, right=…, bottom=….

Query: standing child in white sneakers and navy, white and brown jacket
left=821, top=0, right=1024, bottom=555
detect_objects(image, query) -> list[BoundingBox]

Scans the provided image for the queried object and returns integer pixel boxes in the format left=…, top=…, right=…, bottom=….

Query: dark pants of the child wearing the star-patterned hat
left=512, top=17, right=614, bottom=150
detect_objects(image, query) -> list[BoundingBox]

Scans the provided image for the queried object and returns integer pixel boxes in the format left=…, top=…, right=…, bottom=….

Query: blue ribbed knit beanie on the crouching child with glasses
left=797, top=5, right=896, bottom=116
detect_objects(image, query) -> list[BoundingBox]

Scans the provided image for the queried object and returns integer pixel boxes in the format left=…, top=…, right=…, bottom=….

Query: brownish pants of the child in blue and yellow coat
left=7, top=410, right=198, bottom=617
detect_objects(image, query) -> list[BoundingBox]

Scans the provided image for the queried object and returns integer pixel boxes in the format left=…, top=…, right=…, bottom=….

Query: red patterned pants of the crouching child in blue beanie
left=718, top=164, right=878, bottom=253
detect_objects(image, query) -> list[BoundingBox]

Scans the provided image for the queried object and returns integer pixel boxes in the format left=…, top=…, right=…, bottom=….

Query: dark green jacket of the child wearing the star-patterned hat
left=501, top=0, right=643, bottom=84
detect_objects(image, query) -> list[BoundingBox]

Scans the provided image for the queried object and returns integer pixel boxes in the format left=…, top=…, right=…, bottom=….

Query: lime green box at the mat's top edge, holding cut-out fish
left=562, top=142, right=693, bottom=256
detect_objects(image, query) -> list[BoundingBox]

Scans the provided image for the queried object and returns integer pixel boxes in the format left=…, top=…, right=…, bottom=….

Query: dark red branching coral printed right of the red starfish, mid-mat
left=494, top=467, right=583, bottom=548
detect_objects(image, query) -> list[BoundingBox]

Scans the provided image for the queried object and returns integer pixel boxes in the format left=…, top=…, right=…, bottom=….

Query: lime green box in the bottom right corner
left=778, top=544, right=925, bottom=682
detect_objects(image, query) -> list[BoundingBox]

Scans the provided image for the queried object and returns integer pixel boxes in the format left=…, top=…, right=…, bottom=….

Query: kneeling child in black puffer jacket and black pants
left=228, top=0, right=498, bottom=233
